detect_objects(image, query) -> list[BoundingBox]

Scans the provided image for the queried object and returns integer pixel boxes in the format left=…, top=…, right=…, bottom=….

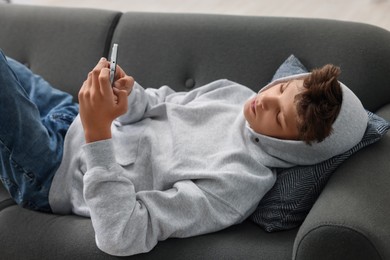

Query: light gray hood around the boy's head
left=246, top=73, right=368, bottom=167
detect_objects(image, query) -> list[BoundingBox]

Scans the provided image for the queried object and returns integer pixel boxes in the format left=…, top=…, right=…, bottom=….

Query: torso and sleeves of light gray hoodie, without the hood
left=49, top=75, right=367, bottom=256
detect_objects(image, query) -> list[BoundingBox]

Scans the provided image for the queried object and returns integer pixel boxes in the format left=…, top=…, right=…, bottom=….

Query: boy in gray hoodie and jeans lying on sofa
left=0, top=51, right=367, bottom=255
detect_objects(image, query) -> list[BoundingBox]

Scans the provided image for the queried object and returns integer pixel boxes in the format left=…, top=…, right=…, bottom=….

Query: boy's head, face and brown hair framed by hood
left=244, top=65, right=343, bottom=144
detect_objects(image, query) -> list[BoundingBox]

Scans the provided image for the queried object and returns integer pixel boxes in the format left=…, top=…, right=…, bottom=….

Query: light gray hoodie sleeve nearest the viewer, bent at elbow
left=84, top=140, right=272, bottom=256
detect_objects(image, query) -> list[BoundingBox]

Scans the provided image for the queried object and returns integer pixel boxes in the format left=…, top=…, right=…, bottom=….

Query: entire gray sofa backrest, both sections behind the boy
left=0, top=5, right=390, bottom=112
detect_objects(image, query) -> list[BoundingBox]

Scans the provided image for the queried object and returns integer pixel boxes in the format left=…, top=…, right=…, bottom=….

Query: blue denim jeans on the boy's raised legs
left=0, top=50, right=78, bottom=212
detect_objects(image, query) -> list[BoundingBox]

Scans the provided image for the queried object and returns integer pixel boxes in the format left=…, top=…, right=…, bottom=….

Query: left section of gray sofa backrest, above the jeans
left=0, top=4, right=121, bottom=98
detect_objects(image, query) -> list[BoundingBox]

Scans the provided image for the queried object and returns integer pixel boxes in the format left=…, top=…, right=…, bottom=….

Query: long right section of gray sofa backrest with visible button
left=113, top=13, right=390, bottom=111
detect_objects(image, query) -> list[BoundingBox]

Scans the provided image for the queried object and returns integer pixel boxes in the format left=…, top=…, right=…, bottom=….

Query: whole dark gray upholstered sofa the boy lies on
left=0, top=4, right=390, bottom=260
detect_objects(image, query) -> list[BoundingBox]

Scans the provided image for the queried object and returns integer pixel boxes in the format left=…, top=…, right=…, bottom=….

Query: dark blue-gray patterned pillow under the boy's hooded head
left=250, top=55, right=390, bottom=232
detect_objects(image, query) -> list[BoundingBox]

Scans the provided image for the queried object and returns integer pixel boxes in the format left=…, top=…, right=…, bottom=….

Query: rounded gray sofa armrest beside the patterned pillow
left=293, top=105, right=390, bottom=260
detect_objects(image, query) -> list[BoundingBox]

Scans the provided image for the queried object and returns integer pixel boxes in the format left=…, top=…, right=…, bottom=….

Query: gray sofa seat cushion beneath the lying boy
left=0, top=205, right=296, bottom=260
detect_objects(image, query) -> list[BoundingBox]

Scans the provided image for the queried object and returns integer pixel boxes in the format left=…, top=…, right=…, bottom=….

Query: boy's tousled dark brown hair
left=296, top=64, right=343, bottom=144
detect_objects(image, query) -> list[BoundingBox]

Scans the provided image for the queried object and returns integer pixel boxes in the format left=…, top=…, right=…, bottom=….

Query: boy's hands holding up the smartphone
left=78, top=58, right=130, bottom=143
